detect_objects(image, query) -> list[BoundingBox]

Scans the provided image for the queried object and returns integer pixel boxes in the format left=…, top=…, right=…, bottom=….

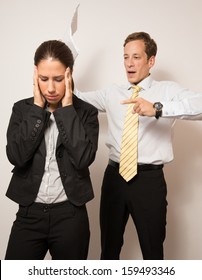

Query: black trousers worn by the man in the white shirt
left=100, top=162, right=167, bottom=260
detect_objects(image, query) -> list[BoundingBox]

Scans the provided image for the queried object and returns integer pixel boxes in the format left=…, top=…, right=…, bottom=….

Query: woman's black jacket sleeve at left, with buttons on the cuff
left=6, top=101, right=50, bottom=167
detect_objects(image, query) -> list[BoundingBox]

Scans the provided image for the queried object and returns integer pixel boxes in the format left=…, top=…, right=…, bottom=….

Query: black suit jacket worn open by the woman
left=6, top=96, right=99, bottom=206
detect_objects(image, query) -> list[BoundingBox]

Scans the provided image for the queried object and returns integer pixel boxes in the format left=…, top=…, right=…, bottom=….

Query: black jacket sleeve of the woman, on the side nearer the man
left=54, top=105, right=99, bottom=169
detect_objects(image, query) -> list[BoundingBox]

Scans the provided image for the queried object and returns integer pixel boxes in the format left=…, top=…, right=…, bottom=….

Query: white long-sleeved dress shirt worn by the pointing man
left=75, top=75, right=202, bottom=164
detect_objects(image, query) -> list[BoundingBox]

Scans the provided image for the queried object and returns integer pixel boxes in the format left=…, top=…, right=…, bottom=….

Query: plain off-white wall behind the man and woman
left=0, top=0, right=202, bottom=260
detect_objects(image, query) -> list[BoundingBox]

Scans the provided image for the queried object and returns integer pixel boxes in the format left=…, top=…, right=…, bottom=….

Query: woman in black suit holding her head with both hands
left=5, top=40, right=99, bottom=260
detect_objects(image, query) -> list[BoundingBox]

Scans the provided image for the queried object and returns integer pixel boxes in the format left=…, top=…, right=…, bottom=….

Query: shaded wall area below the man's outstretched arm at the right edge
left=165, top=120, right=202, bottom=260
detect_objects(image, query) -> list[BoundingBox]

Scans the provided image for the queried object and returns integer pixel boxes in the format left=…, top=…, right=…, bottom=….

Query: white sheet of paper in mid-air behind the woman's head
left=66, top=4, right=80, bottom=60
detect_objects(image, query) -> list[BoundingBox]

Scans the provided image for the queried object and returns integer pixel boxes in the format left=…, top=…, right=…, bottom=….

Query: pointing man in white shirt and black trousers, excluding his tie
left=76, top=32, right=202, bottom=260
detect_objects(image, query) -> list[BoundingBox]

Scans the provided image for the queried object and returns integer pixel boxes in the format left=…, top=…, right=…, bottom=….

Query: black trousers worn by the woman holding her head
left=5, top=201, right=90, bottom=260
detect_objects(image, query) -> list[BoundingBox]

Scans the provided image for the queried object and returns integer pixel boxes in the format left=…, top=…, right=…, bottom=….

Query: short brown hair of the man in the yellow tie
left=123, top=32, right=157, bottom=59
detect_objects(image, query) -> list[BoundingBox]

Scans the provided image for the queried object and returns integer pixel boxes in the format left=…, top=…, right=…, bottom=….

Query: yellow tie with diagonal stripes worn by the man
left=119, top=86, right=141, bottom=182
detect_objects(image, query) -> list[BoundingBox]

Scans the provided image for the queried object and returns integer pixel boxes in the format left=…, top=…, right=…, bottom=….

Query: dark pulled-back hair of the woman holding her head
left=34, top=40, right=74, bottom=71
